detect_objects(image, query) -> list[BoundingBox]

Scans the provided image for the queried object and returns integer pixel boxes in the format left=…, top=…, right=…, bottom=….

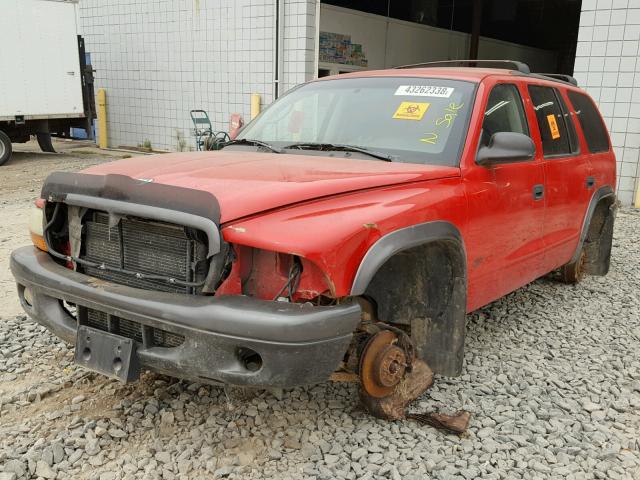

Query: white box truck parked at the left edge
left=0, top=0, right=95, bottom=165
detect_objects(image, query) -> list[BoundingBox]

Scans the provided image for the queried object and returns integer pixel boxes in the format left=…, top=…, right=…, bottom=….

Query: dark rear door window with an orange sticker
left=529, top=85, right=577, bottom=157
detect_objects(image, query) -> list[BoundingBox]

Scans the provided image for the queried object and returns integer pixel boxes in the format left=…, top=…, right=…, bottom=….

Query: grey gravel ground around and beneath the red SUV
left=0, top=144, right=640, bottom=480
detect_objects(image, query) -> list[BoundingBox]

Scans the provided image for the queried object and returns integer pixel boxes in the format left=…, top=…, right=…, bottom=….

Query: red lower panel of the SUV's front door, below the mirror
left=467, top=162, right=544, bottom=310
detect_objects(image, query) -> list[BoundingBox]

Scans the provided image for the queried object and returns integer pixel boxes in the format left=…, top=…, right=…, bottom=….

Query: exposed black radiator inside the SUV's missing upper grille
left=80, top=211, right=209, bottom=294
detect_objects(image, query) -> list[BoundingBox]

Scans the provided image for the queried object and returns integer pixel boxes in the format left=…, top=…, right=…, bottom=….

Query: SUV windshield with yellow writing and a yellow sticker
left=238, top=77, right=475, bottom=166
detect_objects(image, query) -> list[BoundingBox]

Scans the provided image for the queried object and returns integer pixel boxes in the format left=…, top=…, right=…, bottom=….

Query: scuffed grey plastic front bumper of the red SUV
left=11, top=247, right=360, bottom=388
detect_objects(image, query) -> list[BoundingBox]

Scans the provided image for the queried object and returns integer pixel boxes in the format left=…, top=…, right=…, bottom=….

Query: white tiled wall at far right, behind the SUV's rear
left=574, top=0, right=640, bottom=204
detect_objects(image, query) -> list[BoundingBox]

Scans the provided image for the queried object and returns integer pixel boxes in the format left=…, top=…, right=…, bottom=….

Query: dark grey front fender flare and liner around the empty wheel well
left=351, top=221, right=467, bottom=376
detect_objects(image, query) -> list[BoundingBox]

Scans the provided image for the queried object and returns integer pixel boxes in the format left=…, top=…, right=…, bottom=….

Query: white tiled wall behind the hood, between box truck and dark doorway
left=79, top=0, right=319, bottom=150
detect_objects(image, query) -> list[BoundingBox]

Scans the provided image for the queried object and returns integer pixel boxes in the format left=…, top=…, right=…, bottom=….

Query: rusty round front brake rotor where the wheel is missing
left=360, top=330, right=407, bottom=398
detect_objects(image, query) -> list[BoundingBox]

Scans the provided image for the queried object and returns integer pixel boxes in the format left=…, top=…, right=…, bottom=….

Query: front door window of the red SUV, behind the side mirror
left=480, top=83, right=529, bottom=145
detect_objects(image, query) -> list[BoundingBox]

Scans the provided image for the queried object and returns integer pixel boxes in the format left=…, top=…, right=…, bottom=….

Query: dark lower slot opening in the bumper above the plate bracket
left=79, top=307, right=184, bottom=348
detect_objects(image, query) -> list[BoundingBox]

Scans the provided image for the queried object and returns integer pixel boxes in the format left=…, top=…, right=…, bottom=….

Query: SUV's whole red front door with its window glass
left=464, top=83, right=545, bottom=310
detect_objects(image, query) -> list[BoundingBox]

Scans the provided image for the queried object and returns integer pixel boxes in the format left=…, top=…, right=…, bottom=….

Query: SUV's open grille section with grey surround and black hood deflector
left=42, top=173, right=229, bottom=294
